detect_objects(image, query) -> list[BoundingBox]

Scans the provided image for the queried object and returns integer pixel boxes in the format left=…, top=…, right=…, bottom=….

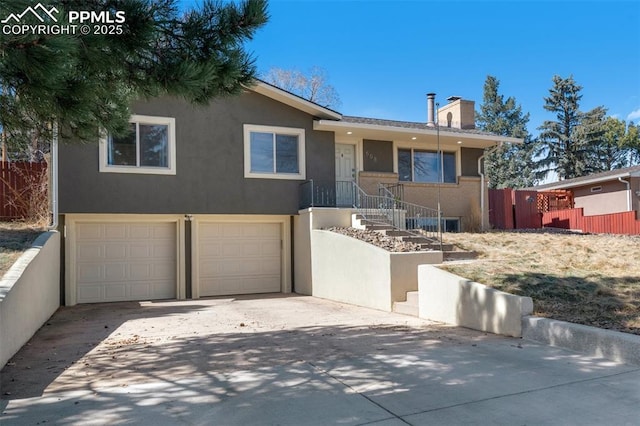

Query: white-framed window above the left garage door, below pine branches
left=100, top=115, right=176, bottom=175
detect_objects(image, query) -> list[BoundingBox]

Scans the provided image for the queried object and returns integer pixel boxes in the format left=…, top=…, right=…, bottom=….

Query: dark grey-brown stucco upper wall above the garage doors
left=59, top=92, right=335, bottom=214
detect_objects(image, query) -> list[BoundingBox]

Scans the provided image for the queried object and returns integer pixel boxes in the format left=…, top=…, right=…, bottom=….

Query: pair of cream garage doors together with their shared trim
left=65, top=215, right=291, bottom=305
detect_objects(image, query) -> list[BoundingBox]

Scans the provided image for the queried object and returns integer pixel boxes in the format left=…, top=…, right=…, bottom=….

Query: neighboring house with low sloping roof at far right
left=530, top=166, right=640, bottom=216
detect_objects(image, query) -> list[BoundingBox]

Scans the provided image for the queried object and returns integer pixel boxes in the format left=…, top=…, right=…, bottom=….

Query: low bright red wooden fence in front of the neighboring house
left=542, top=208, right=640, bottom=235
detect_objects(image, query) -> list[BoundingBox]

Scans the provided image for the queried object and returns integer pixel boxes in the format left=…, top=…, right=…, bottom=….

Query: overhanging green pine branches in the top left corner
left=0, top=0, right=268, bottom=155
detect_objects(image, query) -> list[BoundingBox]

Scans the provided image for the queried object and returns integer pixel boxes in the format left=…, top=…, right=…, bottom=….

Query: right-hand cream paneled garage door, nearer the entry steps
left=197, top=222, right=282, bottom=296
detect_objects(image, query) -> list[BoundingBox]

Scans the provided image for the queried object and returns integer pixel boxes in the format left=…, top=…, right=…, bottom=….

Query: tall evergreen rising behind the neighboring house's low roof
left=537, top=75, right=604, bottom=179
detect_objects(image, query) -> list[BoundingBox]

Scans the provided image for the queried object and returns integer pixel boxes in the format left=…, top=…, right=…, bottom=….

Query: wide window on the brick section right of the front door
left=398, top=148, right=456, bottom=183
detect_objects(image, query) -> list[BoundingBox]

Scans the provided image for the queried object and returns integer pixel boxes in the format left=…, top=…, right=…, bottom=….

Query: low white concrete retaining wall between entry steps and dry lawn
left=418, top=265, right=533, bottom=337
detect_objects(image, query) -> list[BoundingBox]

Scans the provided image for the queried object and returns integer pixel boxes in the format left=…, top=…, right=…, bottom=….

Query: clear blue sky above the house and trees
left=232, top=0, right=640, bottom=134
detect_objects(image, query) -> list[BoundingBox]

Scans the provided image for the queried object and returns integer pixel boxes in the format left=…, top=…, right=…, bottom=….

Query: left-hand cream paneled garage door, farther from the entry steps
left=75, top=222, right=176, bottom=303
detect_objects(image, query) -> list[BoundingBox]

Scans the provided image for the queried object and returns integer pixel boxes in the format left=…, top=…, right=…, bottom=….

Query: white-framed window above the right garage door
left=244, top=124, right=305, bottom=179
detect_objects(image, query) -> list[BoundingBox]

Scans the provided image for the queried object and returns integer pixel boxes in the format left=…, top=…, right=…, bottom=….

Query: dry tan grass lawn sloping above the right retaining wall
left=445, top=232, right=640, bottom=335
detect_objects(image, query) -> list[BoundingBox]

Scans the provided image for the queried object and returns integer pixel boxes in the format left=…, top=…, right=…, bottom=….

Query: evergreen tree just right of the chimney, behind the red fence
left=476, top=76, right=536, bottom=188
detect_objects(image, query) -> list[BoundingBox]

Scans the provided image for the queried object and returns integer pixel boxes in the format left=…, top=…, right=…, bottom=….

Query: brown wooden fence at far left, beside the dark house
left=0, top=161, right=49, bottom=221
